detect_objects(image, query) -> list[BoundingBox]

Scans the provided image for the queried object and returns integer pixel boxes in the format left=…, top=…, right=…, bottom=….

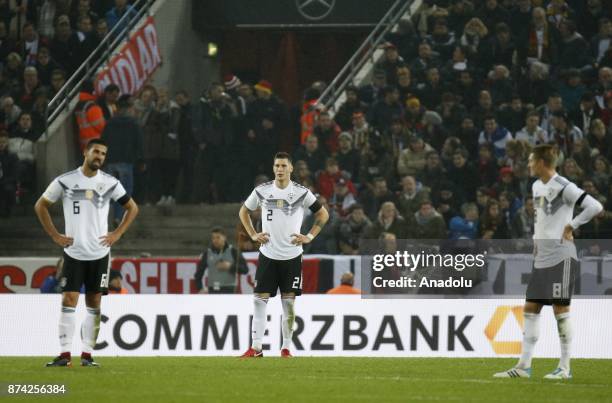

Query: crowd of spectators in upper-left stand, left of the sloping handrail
left=0, top=0, right=139, bottom=216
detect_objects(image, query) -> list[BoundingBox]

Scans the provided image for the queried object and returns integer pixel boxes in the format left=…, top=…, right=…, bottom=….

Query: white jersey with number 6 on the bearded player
left=43, top=167, right=126, bottom=260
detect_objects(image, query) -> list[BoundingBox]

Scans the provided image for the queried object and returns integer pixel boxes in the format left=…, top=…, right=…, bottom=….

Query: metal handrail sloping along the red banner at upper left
left=45, top=0, right=155, bottom=133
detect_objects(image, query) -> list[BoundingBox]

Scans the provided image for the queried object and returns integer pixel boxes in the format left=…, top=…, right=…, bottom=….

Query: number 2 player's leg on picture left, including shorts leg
left=241, top=253, right=278, bottom=358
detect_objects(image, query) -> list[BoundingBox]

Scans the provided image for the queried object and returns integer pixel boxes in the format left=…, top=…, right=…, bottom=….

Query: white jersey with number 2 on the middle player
left=244, top=181, right=317, bottom=260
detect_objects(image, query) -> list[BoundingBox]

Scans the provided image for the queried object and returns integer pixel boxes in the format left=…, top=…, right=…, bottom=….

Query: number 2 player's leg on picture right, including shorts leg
left=280, top=255, right=302, bottom=357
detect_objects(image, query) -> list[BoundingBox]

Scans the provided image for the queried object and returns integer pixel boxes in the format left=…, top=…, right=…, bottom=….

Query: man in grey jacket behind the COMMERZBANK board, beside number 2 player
left=195, top=227, right=249, bottom=294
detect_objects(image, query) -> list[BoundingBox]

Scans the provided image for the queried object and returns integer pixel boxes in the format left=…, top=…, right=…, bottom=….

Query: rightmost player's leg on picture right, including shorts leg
left=544, top=259, right=578, bottom=379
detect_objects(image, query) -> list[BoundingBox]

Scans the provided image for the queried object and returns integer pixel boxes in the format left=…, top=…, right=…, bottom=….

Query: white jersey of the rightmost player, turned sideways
left=532, top=174, right=585, bottom=268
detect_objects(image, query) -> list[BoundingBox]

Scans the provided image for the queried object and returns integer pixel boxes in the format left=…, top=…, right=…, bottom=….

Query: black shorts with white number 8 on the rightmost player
left=526, top=258, right=578, bottom=305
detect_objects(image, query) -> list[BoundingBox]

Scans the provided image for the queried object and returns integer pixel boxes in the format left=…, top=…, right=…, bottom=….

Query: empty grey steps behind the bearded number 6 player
left=0, top=204, right=240, bottom=257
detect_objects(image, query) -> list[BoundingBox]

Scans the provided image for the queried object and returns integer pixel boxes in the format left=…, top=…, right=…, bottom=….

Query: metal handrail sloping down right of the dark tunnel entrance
left=316, top=0, right=414, bottom=110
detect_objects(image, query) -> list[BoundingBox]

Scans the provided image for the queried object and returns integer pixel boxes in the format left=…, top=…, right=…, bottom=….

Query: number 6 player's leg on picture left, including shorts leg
left=47, top=253, right=83, bottom=367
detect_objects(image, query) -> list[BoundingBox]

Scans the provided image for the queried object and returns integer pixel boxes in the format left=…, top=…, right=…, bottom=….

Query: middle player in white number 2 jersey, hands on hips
left=239, top=152, right=329, bottom=358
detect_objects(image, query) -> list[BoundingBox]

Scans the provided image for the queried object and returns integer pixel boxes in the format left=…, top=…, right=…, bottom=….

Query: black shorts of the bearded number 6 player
left=60, top=252, right=110, bottom=294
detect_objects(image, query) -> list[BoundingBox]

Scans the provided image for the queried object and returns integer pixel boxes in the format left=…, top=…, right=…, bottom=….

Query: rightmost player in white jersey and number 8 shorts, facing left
left=494, top=144, right=603, bottom=379
